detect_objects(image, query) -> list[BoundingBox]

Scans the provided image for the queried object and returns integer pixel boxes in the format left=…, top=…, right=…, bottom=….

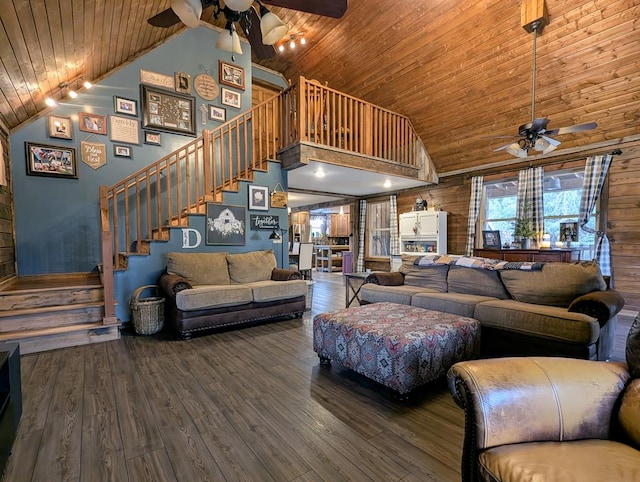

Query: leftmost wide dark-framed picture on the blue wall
left=24, top=142, right=78, bottom=179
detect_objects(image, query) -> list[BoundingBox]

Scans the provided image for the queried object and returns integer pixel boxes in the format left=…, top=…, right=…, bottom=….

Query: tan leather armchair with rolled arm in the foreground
left=447, top=357, right=640, bottom=482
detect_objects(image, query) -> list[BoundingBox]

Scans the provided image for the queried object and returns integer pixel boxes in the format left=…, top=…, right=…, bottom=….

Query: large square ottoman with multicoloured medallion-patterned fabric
left=313, top=303, right=480, bottom=395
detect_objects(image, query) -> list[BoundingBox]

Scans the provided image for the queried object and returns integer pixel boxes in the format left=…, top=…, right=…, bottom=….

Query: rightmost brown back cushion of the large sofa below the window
left=499, top=261, right=607, bottom=308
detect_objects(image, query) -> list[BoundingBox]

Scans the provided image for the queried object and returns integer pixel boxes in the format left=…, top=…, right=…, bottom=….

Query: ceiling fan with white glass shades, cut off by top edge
left=147, top=0, right=347, bottom=59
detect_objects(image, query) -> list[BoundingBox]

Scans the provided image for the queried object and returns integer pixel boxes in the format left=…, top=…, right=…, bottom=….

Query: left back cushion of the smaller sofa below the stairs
left=166, top=253, right=230, bottom=286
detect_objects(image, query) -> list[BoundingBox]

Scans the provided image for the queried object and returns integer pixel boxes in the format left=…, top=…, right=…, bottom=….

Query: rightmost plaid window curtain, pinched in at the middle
left=578, top=154, right=612, bottom=276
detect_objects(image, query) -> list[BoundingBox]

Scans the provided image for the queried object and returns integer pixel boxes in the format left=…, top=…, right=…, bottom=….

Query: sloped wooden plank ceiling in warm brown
left=0, top=0, right=640, bottom=174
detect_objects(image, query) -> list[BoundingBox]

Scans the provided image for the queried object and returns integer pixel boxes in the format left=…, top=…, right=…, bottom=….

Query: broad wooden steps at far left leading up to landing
left=0, top=273, right=120, bottom=354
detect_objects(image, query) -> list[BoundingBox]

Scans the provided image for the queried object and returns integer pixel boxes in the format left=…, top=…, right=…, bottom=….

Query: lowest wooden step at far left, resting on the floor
left=0, top=322, right=120, bottom=355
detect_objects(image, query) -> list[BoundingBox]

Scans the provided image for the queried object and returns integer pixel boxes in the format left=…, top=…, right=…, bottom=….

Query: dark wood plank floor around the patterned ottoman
left=3, top=272, right=628, bottom=482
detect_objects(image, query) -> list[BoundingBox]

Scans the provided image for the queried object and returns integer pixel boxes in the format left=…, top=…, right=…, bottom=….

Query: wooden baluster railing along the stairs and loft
left=100, top=77, right=426, bottom=322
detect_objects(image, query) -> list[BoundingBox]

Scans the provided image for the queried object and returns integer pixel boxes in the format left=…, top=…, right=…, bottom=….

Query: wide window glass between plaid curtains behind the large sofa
left=479, top=170, right=597, bottom=247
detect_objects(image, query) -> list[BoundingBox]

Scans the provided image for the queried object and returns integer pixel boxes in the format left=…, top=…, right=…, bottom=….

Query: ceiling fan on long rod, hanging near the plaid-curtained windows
left=492, top=18, right=598, bottom=157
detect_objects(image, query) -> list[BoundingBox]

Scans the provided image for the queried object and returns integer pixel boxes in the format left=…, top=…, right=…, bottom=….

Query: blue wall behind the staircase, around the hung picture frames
left=10, top=26, right=287, bottom=274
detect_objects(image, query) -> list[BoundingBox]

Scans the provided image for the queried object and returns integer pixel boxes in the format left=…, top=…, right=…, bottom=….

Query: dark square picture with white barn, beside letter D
left=205, top=203, right=246, bottom=245
